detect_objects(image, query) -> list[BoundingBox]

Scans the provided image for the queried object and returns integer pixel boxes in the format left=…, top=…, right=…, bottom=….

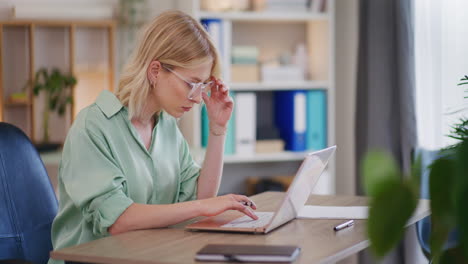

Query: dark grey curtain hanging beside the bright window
left=356, top=0, right=416, bottom=263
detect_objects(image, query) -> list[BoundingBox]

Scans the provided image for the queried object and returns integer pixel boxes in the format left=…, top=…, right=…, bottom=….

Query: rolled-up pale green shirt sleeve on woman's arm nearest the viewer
left=61, top=127, right=133, bottom=236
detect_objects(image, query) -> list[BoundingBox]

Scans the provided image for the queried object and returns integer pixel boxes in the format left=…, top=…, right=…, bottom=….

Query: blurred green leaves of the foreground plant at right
left=362, top=76, right=468, bottom=264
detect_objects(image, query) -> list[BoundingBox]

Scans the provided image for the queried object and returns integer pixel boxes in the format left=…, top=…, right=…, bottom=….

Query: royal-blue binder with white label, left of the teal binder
left=275, top=90, right=307, bottom=151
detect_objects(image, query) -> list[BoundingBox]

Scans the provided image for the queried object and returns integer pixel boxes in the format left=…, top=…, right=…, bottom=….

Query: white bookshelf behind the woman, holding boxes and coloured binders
left=177, top=0, right=335, bottom=193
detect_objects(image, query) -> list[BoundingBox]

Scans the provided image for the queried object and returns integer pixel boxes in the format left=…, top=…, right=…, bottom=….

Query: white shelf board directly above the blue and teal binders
left=230, top=81, right=328, bottom=91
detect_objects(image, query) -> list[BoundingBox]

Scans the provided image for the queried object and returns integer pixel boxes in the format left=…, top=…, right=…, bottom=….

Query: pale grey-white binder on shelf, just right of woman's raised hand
left=234, top=92, right=257, bottom=155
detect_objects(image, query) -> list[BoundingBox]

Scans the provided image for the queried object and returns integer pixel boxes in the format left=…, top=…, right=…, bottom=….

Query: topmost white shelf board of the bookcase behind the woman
left=200, top=11, right=329, bottom=22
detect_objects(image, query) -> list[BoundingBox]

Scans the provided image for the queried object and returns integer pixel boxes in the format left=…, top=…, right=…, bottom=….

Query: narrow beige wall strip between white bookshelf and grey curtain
left=335, top=0, right=359, bottom=194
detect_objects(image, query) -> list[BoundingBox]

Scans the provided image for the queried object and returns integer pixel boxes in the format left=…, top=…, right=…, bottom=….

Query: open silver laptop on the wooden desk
left=185, top=146, right=336, bottom=234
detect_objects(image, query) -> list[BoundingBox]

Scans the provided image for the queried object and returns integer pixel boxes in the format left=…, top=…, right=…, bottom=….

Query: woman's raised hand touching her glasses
left=202, top=77, right=234, bottom=128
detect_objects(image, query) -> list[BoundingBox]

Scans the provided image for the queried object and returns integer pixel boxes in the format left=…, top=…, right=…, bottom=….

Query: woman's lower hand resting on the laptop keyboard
left=199, top=194, right=258, bottom=220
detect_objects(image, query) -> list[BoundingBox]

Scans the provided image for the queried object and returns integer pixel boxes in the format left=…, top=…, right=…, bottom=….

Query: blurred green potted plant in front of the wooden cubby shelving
left=32, top=68, right=76, bottom=151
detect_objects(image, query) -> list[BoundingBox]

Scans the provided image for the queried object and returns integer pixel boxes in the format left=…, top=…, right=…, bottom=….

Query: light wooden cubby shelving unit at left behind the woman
left=0, top=19, right=116, bottom=143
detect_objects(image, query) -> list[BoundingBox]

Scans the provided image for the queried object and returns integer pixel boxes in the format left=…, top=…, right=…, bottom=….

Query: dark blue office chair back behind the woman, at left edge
left=0, top=122, right=58, bottom=264
